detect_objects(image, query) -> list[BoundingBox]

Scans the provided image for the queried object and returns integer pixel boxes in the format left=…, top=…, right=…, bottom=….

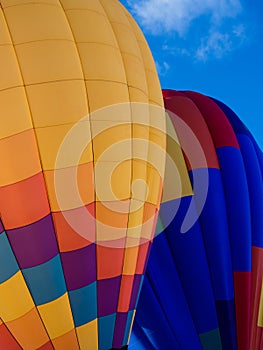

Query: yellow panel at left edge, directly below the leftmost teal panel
left=0, top=271, right=34, bottom=322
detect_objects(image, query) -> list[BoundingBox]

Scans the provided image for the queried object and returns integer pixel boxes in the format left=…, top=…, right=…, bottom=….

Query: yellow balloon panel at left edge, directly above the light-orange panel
left=0, top=86, right=33, bottom=139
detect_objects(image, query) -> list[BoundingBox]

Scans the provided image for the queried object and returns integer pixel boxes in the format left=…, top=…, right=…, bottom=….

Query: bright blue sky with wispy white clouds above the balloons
left=121, top=0, right=263, bottom=149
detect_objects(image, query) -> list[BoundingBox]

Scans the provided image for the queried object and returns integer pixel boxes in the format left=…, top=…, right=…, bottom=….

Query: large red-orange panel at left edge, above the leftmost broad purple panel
left=0, top=173, right=50, bottom=229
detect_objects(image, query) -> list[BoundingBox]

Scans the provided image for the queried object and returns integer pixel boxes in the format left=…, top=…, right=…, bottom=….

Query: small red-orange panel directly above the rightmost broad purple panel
left=96, top=245, right=124, bottom=279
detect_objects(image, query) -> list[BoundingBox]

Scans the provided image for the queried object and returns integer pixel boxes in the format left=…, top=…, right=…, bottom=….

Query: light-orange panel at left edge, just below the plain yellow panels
left=0, top=129, right=41, bottom=186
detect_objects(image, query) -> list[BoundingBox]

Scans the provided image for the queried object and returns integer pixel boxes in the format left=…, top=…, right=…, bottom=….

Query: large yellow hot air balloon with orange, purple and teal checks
left=0, top=0, right=165, bottom=350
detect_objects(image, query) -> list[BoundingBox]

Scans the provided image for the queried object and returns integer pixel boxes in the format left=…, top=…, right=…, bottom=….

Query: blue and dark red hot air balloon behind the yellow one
left=130, top=90, right=263, bottom=350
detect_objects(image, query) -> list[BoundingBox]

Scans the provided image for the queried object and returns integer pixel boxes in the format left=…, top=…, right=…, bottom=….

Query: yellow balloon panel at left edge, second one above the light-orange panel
left=0, top=45, right=23, bottom=91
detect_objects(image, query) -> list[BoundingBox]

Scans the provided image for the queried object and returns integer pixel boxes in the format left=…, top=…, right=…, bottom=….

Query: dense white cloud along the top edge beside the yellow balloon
left=129, top=0, right=242, bottom=36
